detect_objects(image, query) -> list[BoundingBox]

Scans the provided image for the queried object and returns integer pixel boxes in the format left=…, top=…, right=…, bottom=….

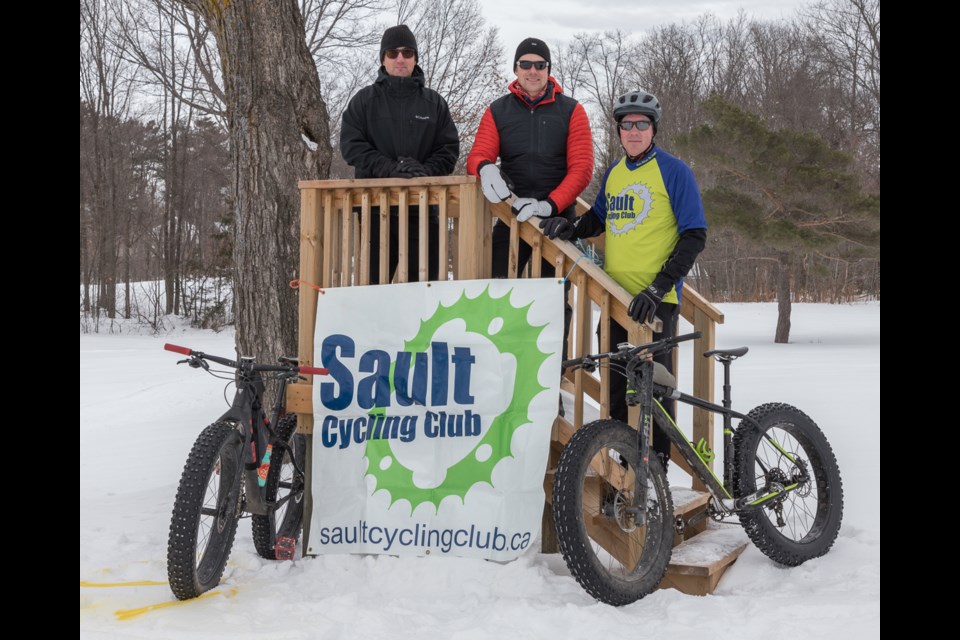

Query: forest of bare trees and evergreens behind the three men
left=80, top=0, right=880, bottom=338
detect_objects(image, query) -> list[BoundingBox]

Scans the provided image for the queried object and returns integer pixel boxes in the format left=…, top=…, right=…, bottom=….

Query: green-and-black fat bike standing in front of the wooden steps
left=553, top=333, right=843, bottom=605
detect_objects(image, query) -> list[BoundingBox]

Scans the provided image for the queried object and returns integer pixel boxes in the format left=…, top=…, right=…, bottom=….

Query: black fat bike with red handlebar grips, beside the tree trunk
left=164, top=344, right=327, bottom=600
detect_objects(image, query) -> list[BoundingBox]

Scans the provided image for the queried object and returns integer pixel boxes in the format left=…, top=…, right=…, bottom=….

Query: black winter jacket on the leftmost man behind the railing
left=340, top=65, right=460, bottom=178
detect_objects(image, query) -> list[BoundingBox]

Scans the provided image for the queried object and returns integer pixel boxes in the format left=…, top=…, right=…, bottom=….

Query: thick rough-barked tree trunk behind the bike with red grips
left=183, top=0, right=331, bottom=362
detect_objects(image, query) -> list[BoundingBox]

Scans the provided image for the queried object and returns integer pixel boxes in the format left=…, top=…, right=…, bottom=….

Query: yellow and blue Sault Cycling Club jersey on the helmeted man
left=593, top=147, right=707, bottom=304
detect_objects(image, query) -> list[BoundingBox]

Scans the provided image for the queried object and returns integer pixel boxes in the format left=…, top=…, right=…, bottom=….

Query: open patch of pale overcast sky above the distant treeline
left=480, top=0, right=815, bottom=77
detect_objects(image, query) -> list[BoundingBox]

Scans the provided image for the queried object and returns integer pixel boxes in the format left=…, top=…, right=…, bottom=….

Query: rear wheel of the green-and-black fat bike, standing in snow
left=734, top=403, right=843, bottom=567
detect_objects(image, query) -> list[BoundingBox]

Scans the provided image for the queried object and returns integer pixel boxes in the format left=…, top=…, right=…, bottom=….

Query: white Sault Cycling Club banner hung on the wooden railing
left=306, top=279, right=563, bottom=560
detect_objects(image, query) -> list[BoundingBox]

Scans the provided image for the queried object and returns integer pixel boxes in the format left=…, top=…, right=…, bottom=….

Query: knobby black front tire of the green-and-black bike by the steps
left=553, top=420, right=673, bottom=606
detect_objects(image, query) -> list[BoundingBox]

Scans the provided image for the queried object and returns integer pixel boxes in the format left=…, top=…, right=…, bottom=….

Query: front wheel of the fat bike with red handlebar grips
left=167, top=422, right=242, bottom=600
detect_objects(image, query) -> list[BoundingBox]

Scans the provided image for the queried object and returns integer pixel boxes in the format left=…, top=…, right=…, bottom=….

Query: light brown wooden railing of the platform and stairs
left=288, top=176, right=723, bottom=496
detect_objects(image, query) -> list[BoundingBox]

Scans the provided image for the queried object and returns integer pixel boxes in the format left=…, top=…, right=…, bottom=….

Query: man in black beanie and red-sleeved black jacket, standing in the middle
left=467, top=38, right=593, bottom=278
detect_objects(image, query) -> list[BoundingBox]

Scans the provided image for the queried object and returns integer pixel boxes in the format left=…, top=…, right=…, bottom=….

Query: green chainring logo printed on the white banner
left=365, top=288, right=551, bottom=511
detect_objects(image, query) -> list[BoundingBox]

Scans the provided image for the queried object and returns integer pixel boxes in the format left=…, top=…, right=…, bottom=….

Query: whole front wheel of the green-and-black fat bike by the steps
left=553, top=420, right=673, bottom=606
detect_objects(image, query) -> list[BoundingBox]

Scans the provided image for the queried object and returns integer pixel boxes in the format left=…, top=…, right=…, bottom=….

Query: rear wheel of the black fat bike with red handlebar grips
left=252, top=414, right=307, bottom=560
